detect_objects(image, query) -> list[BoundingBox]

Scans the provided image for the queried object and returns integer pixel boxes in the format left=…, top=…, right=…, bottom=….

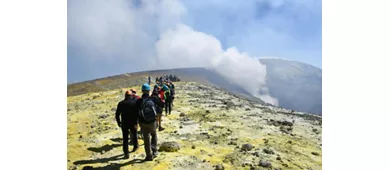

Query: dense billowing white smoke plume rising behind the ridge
left=156, top=24, right=278, bottom=105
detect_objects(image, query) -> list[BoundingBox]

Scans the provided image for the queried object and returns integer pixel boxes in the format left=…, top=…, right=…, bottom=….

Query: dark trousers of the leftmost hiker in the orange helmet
left=122, top=125, right=138, bottom=155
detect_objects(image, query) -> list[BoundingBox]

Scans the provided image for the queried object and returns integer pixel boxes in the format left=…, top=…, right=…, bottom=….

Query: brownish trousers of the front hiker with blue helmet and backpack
left=140, top=122, right=157, bottom=158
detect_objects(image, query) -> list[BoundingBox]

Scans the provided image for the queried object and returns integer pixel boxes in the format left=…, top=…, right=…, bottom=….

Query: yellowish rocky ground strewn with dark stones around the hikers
left=67, top=82, right=322, bottom=170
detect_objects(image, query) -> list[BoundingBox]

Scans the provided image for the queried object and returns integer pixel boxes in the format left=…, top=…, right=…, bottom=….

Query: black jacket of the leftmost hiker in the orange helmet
left=115, top=97, right=138, bottom=126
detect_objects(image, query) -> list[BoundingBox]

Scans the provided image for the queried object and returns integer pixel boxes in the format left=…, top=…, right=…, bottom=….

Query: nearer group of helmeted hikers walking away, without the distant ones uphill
left=115, top=81, right=175, bottom=161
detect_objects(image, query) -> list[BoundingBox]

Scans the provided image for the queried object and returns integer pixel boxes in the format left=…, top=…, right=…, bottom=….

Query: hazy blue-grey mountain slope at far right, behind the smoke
left=260, top=59, right=322, bottom=115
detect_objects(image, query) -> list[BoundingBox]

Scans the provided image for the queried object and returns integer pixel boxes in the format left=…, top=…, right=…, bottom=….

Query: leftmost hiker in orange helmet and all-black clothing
left=115, top=91, right=138, bottom=159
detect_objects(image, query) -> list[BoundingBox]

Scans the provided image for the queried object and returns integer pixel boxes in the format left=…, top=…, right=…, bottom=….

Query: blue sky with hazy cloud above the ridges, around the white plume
left=67, top=0, right=322, bottom=83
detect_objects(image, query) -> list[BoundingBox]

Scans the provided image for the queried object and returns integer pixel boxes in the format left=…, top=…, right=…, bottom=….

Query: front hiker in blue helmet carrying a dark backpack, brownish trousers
left=136, top=83, right=164, bottom=161
